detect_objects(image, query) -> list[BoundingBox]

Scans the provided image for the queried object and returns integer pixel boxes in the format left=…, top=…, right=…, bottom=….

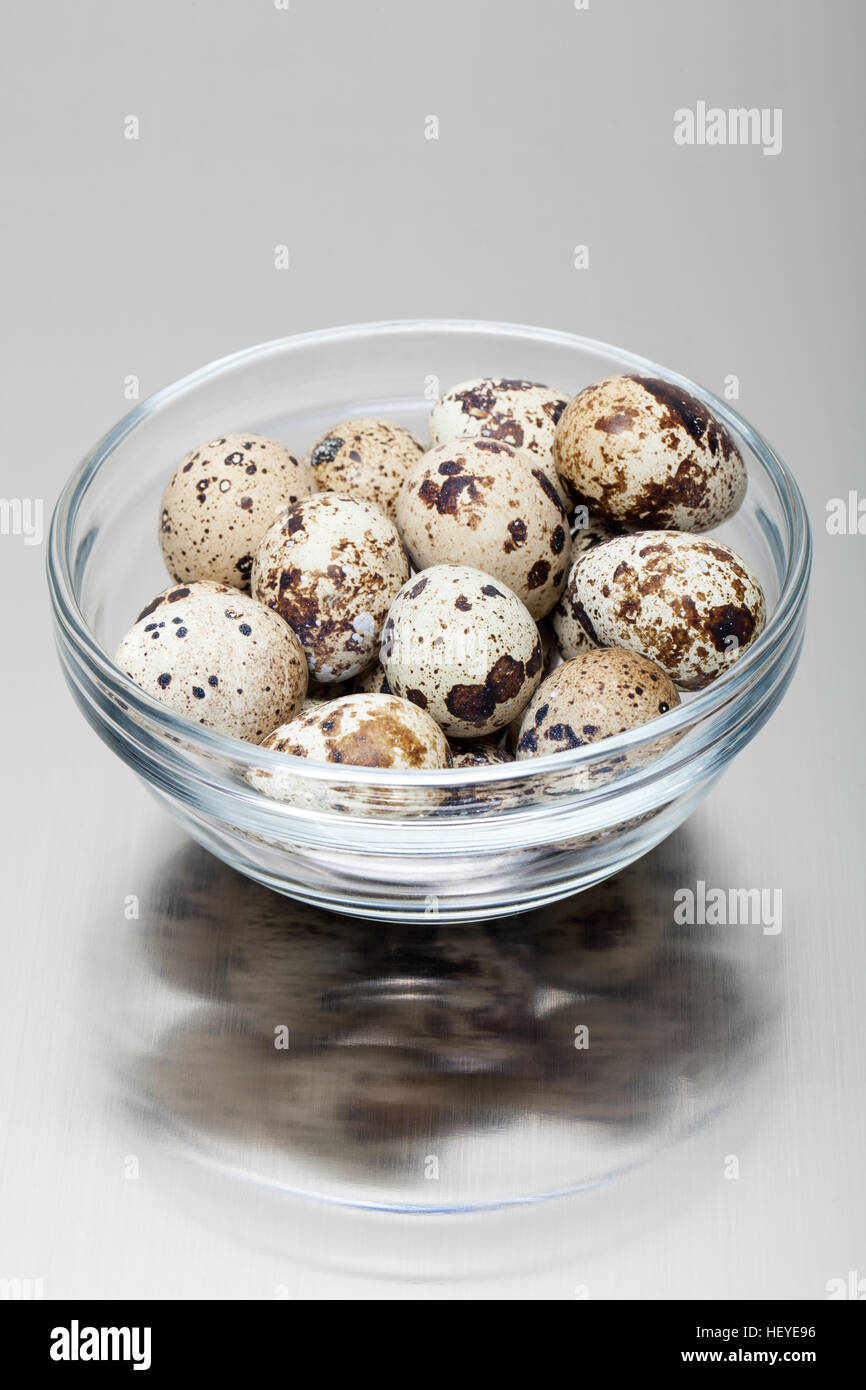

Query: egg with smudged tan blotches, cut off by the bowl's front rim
left=255, top=695, right=452, bottom=769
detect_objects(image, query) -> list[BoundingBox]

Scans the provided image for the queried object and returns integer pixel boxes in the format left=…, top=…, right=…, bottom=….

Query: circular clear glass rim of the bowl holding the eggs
left=46, top=318, right=812, bottom=789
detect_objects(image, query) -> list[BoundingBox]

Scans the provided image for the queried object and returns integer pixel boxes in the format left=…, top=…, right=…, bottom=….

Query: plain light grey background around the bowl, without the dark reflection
left=0, top=0, right=866, bottom=1298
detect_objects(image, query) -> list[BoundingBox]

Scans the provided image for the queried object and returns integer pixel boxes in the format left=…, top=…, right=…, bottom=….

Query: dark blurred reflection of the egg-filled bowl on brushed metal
left=131, top=848, right=762, bottom=1208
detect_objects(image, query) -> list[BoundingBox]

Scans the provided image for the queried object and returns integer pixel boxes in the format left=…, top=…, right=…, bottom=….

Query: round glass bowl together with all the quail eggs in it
left=49, top=321, right=809, bottom=920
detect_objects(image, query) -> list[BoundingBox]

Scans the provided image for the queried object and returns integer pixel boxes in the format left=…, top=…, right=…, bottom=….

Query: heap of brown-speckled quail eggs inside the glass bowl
left=117, top=375, right=766, bottom=799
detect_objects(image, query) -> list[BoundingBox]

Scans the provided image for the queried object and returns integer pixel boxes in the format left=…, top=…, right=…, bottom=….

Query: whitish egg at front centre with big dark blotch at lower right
left=379, top=564, right=542, bottom=739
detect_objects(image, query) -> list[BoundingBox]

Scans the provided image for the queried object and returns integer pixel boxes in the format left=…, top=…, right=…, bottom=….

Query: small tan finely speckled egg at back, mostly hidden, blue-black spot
left=310, top=418, right=424, bottom=520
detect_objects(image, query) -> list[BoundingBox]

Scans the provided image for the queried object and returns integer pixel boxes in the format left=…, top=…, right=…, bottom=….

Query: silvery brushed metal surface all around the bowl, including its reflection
left=0, top=0, right=866, bottom=1298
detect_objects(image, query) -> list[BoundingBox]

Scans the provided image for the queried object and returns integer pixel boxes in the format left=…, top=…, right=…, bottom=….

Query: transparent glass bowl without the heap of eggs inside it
left=49, top=320, right=810, bottom=920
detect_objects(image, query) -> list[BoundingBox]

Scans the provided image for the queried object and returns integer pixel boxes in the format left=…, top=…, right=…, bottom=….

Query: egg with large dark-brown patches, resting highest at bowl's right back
left=553, top=377, right=746, bottom=531
